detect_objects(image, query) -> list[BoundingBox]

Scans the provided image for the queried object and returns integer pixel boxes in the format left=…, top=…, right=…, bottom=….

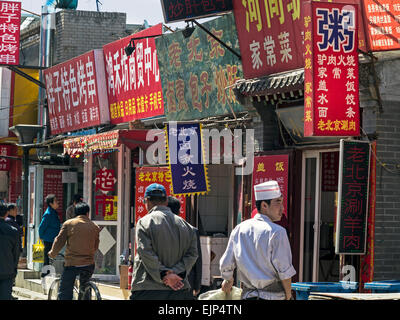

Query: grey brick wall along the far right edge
left=366, top=59, right=400, bottom=280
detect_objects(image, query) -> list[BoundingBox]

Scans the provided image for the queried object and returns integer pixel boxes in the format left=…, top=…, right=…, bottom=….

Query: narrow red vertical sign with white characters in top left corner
left=0, top=1, right=21, bottom=65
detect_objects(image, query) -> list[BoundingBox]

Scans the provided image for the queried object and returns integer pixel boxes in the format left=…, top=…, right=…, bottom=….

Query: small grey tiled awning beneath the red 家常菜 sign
left=234, top=68, right=304, bottom=100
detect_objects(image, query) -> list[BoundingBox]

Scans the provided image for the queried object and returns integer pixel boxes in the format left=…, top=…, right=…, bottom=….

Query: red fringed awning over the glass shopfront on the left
left=64, top=129, right=154, bottom=156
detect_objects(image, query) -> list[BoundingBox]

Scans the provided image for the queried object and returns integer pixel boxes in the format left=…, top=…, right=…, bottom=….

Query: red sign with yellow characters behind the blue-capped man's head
left=135, top=167, right=186, bottom=223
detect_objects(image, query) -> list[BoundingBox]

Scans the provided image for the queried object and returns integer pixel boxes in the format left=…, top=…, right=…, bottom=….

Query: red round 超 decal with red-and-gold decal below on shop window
left=94, top=167, right=118, bottom=221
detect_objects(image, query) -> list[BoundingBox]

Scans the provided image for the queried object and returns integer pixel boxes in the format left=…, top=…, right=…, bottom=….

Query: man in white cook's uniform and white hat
left=220, top=181, right=296, bottom=300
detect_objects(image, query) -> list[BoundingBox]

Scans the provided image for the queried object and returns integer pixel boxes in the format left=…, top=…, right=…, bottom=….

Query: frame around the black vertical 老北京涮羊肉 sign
left=335, top=139, right=371, bottom=255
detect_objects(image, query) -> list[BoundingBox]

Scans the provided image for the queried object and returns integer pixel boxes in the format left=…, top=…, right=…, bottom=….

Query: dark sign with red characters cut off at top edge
left=161, top=0, right=233, bottom=23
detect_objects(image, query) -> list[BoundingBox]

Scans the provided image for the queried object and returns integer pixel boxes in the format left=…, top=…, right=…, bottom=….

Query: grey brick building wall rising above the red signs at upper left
left=53, top=10, right=127, bottom=65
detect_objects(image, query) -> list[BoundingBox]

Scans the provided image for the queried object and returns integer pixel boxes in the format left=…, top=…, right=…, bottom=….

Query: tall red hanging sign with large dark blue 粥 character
left=303, top=2, right=360, bottom=137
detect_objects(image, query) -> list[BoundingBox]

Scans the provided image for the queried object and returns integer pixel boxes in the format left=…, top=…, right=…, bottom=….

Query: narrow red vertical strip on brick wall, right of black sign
left=360, top=141, right=376, bottom=292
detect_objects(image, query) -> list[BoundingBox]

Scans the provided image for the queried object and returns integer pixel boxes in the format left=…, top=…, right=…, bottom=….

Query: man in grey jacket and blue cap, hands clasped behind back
left=130, top=183, right=198, bottom=300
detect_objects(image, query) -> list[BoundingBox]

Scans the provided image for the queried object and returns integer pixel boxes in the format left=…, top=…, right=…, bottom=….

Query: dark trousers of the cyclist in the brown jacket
left=58, top=264, right=94, bottom=300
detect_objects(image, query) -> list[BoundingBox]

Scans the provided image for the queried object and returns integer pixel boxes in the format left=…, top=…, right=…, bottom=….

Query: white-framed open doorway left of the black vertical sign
left=299, top=149, right=339, bottom=282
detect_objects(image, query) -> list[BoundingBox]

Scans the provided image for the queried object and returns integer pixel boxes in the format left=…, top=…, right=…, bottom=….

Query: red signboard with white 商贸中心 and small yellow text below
left=103, top=23, right=164, bottom=124
